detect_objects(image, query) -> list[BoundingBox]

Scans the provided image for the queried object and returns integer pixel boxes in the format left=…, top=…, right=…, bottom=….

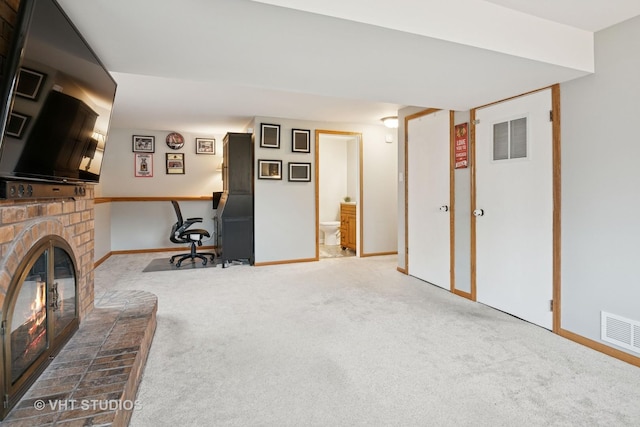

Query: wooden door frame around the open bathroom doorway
left=315, top=129, right=364, bottom=261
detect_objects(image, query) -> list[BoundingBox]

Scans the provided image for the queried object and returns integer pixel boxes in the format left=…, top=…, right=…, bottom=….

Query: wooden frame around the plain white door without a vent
left=403, top=108, right=458, bottom=297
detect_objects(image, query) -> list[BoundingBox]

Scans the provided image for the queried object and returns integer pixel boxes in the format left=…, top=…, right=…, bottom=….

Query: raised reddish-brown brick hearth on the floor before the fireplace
left=1, top=291, right=157, bottom=427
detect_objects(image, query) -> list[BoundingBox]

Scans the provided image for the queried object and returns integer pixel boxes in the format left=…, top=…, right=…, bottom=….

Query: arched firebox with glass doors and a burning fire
left=0, top=235, right=79, bottom=419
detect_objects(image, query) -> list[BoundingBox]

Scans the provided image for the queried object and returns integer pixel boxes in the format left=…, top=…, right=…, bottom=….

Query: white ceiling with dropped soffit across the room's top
left=58, top=0, right=640, bottom=134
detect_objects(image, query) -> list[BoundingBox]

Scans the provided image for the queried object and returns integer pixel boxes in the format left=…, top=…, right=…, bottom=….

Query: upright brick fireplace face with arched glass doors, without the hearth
left=0, top=187, right=94, bottom=419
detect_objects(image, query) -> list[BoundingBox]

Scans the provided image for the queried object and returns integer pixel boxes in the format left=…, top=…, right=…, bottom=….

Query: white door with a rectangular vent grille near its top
left=473, top=89, right=553, bottom=329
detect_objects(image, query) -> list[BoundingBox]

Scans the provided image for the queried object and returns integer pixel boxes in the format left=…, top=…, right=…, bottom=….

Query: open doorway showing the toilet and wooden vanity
left=315, top=130, right=362, bottom=259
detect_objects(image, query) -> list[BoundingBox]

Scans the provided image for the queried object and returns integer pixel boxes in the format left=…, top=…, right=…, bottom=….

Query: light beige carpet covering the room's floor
left=96, top=254, right=640, bottom=427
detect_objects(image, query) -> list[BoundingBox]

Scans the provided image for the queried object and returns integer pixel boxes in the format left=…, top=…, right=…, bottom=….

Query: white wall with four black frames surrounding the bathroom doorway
left=254, top=117, right=397, bottom=263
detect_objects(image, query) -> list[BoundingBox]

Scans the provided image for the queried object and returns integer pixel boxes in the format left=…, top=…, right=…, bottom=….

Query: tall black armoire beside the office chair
left=216, top=133, right=254, bottom=268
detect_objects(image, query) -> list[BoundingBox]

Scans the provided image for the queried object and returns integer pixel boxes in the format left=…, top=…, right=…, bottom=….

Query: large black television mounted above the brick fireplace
left=0, top=0, right=116, bottom=196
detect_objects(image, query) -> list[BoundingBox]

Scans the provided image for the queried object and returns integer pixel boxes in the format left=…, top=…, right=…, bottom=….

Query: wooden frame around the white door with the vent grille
left=469, top=84, right=562, bottom=333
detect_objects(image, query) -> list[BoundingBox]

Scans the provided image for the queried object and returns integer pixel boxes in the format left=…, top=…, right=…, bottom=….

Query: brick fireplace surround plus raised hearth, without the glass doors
left=0, top=185, right=157, bottom=426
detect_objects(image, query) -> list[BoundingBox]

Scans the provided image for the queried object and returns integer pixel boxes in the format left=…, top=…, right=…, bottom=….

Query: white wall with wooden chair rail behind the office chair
left=94, top=128, right=224, bottom=254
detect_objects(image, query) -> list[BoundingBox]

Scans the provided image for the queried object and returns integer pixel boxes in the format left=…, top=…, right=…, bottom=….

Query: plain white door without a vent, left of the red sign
left=407, top=111, right=451, bottom=289
